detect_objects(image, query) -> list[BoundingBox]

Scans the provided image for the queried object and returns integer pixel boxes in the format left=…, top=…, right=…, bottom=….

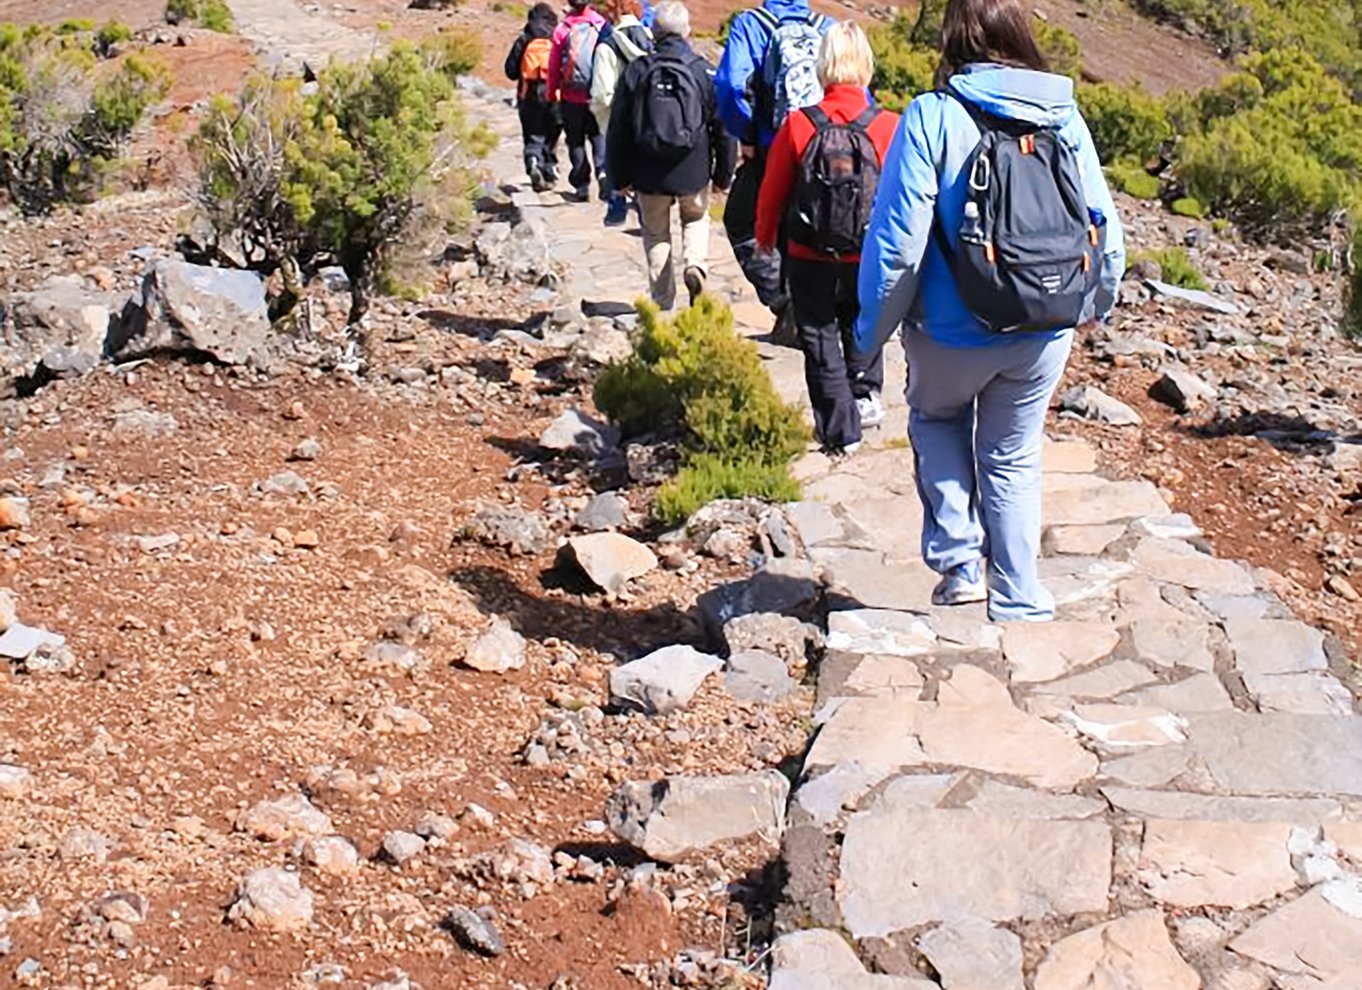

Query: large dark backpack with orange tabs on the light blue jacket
left=936, top=87, right=1106, bottom=334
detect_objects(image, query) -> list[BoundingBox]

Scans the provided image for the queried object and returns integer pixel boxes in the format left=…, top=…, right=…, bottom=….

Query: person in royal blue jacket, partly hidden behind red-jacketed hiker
left=714, top=0, right=832, bottom=340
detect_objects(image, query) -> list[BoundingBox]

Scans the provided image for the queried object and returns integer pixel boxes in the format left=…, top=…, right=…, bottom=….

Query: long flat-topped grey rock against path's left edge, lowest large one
left=606, top=769, right=790, bottom=862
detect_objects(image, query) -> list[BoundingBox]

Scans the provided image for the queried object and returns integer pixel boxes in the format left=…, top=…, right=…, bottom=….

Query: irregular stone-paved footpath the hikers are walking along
left=479, top=83, right=1362, bottom=990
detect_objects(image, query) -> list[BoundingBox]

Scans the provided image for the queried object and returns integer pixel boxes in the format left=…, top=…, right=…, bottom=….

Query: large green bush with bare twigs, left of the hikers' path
left=191, top=42, right=494, bottom=320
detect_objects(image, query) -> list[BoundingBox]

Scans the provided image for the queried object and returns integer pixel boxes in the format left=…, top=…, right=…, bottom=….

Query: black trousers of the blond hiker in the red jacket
left=787, top=257, right=884, bottom=447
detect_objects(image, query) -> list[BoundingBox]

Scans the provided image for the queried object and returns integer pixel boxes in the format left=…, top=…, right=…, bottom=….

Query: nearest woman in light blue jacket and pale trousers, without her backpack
left=855, top=0, right=1125, bottom=621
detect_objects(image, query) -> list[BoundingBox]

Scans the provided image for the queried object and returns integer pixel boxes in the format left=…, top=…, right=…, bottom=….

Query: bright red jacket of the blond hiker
left=757, top=86, right=899, bottom=261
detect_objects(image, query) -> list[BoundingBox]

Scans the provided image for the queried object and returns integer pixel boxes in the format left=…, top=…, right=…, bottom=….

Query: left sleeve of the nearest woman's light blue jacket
left=854, top=94, right=945, bottom=354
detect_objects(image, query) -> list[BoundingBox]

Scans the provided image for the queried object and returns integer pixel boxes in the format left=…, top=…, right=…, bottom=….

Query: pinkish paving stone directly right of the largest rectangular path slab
left=1137, top=820, right=1297, bottom=911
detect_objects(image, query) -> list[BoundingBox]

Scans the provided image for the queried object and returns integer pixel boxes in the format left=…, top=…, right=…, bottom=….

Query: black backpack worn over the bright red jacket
left=786, top=106, right=881, bottom=255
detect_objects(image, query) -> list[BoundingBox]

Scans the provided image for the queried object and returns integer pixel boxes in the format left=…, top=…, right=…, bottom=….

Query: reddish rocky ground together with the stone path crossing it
left=0, top=3, right=1362, bottom=990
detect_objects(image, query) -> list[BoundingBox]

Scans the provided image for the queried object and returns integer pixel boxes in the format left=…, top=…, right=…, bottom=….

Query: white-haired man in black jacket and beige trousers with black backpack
left=606, top=0, right=737, bottom=309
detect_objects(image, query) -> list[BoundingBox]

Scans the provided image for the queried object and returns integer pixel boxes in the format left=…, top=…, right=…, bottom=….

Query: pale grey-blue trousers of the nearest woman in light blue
left=903, top=328, right=1073, bottom=622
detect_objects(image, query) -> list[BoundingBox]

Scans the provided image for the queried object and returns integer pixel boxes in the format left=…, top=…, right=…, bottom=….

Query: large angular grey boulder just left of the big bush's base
left=117, top=259, right=270, bottom=365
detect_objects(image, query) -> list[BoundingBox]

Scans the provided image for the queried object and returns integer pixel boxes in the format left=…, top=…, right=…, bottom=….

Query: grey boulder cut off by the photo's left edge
left=0, top=275, right=118, bottom=398
